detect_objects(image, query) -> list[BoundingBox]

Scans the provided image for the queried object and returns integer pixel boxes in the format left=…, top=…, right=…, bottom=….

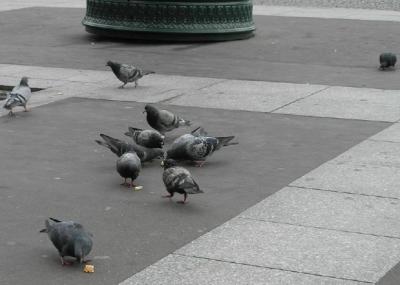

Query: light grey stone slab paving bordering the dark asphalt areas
left=0, top=1, right=400, bottom=285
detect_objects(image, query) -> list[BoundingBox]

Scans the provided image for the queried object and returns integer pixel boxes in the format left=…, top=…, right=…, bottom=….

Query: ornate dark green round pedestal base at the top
left=82, top=0, right=255, bottom=41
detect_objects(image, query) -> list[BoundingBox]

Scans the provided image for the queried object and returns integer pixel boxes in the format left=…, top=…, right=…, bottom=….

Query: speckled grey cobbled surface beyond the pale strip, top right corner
left=253, top=0, right=400, bottom=11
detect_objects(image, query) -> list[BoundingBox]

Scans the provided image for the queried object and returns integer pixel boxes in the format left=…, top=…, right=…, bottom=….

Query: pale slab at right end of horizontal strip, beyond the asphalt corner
left=276, top=87, right=400, bottom=122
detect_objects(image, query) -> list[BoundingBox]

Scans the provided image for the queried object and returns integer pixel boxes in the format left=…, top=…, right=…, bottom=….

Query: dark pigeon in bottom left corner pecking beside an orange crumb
left=40, top=218, right=93, bottom=265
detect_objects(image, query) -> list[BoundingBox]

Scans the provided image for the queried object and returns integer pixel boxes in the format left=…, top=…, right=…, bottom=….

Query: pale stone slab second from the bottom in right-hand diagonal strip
left=177, top=218, right=400, bottom=282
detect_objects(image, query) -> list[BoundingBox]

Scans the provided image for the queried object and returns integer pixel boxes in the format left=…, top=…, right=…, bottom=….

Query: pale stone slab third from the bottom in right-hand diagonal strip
left=240, top=187, right=400, bottom=238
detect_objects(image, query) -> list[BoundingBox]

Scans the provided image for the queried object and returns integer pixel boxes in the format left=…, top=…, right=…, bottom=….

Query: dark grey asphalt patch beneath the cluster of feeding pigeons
left=0, top=97, right=388, bottom=285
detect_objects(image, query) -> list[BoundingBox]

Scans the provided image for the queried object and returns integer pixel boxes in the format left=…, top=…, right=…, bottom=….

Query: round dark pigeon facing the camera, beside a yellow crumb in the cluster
left=117, top=152, right=142, bottom=187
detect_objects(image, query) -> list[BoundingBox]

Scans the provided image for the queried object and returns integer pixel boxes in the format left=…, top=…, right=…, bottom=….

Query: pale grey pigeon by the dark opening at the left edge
left=3, top=76, right=32, bottom=116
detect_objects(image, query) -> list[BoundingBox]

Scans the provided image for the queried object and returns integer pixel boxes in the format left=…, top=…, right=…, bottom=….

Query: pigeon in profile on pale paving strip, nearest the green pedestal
left=106, top=60, right=155, bottom=88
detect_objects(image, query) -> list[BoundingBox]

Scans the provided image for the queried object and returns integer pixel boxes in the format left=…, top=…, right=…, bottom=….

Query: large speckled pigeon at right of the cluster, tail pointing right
left=166, top=127, right=238, bottom=166
